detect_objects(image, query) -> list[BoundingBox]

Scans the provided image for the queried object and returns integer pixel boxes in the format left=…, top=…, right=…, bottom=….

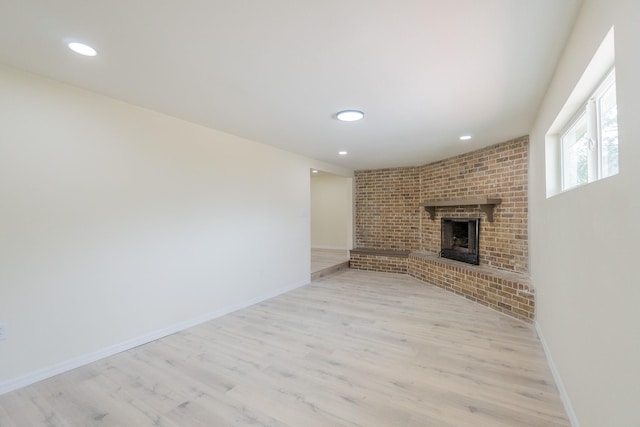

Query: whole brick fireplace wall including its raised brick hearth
left=351, top=136, right=534, bottom=321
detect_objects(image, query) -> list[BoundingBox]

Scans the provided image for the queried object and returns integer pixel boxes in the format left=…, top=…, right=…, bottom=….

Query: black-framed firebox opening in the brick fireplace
left=440, top=218, right=480, bottom=265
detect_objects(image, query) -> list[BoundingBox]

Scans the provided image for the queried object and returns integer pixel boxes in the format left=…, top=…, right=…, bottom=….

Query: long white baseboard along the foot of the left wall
left=0, top=281, right=309, bottom=395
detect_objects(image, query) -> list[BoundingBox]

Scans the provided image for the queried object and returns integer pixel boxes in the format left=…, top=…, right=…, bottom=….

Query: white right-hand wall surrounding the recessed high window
left=530, top=0, right=640, bottom=427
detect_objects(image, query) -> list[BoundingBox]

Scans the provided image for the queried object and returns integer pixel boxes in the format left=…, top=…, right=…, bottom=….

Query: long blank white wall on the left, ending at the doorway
left=0, top=67, right=350, bottom=392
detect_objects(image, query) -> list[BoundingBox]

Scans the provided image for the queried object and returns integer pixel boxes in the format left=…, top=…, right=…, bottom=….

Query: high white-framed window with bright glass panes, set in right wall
left=560, top=69, right=618, bottom=191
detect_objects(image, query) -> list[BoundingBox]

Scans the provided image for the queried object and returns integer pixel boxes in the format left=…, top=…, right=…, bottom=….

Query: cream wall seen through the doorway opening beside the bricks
left=311, top=172, right=353, bottom=249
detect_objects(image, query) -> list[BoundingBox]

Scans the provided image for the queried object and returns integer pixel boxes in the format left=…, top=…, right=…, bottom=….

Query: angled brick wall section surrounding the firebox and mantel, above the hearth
left=420, top=136, right=529, bottom=273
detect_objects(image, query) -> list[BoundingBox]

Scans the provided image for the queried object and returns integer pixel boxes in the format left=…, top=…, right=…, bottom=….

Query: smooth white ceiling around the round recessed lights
left=0, top=0, right=581, bottom=169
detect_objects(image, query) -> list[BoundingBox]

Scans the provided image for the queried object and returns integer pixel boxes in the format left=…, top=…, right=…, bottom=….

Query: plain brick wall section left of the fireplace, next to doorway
left=355, top=167, right=420, bottom=250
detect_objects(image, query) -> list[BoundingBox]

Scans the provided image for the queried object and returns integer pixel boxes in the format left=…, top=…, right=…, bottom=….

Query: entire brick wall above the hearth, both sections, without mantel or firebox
left=355, top=136, right=529, bottom=273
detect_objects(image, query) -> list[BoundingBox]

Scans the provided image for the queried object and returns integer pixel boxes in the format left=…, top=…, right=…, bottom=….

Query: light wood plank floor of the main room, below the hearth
left=0, top=270, right=569, bottom=427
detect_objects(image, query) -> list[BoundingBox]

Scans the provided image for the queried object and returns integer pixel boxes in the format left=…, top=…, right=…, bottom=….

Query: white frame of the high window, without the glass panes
left=560, top=67, right=618, bottom=192
